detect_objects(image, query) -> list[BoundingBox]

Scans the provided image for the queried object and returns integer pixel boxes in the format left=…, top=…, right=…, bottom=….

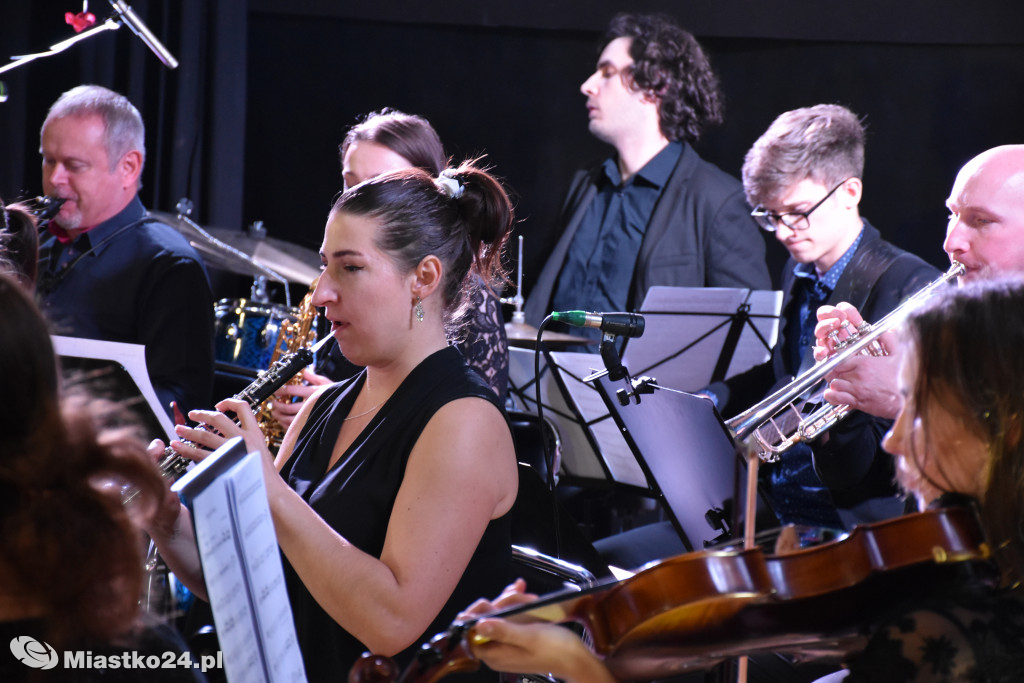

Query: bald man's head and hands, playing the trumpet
left=814, top=144, right=1024, bottom=421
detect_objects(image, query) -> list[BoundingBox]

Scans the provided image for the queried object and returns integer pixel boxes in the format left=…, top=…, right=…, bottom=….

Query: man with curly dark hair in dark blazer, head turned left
left=526, top=14, right=771, bottom=332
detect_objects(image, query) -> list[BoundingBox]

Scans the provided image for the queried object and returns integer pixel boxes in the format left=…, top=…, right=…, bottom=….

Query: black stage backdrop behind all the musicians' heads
left=0, top=0, right=1024, bottom=296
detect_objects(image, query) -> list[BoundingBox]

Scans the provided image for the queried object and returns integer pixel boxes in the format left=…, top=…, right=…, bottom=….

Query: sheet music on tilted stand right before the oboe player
left=173, top=437, right=306, bottom=683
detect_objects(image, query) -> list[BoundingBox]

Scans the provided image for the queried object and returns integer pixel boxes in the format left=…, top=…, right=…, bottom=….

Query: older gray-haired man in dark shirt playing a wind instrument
left=38, top=85, right=213, bottom=414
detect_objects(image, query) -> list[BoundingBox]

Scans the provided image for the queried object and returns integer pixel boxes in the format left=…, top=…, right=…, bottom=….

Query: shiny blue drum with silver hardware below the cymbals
left=214, top=299, right=299, bottom=371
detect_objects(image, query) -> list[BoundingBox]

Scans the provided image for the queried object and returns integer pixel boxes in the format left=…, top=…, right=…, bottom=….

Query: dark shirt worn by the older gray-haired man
left=39, top=197, right=213, bottom=414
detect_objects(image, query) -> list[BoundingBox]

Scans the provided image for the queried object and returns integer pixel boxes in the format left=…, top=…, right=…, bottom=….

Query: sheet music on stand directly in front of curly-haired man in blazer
left=623, top=287, right=782, bottom=391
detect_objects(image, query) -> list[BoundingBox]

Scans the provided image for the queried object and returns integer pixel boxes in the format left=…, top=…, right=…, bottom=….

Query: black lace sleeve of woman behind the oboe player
left=459, top=283, right=509, bottom=402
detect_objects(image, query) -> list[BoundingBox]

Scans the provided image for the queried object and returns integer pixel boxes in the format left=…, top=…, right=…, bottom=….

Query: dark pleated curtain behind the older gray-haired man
left=0, top=0, right=248, bottom=229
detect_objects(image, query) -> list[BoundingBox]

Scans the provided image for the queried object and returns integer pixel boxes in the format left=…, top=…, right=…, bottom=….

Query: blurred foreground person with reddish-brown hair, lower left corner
left=0, top=272, right=197, bottom=681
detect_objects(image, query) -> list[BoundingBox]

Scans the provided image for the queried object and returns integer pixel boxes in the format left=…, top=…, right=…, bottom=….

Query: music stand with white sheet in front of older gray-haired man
left=50, top=335, right=177, bottom=441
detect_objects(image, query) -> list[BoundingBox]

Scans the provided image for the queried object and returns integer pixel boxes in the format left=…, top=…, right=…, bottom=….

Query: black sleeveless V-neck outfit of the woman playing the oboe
left=281, top=347, right=514, bottom=683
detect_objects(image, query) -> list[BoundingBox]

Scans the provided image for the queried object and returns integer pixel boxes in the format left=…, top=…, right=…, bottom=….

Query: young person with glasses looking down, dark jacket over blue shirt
left=709, top=104, right=939, bottom=529
